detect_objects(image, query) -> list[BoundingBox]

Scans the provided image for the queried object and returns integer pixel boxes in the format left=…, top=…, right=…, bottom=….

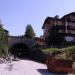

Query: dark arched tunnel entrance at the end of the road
left=9, top=43, right=30, bottom=58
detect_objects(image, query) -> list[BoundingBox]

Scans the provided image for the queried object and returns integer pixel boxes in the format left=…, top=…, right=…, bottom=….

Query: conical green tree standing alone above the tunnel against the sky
left=25, top=25, right=35, bottom=39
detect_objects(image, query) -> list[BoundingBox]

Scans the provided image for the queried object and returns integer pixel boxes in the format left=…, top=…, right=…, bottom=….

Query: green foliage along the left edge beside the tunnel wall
left=0, top=24, right=8, bottom=57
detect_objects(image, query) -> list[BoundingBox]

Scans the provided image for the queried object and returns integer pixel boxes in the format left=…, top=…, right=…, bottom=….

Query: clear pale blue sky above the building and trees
left=0, top=0, right=75, bottom=37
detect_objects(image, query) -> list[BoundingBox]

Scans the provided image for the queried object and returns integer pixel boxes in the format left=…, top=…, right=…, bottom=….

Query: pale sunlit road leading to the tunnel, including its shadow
left=0, top=60, right=72, bottom=75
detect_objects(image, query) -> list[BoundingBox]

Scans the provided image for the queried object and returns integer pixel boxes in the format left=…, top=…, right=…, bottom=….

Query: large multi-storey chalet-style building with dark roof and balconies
left=42, top=12, right=75, bottom=46
